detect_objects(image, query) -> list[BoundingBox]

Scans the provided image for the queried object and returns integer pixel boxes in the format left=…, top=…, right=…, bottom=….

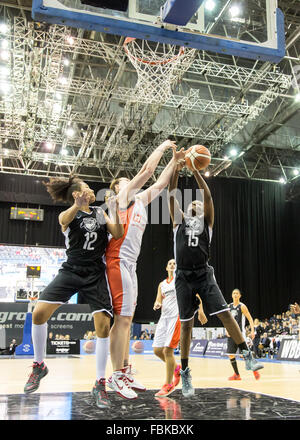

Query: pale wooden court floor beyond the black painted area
left=0, top=355, right=300, bottom=402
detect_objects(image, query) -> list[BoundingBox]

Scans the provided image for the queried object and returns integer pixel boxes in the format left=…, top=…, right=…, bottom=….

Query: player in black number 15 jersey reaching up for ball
left=169, top=161, right=263, bottom=397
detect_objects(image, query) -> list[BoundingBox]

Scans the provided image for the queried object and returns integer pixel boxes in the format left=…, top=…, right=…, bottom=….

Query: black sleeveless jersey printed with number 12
left=64, top=206, right=108, bottom=266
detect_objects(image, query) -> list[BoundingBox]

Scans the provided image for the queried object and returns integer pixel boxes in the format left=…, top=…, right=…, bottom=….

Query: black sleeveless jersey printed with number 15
left=174, top=215, right=210, bottom=270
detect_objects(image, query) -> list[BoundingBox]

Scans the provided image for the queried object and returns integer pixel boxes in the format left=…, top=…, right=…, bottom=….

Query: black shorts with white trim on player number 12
left=39, top=262, right=113, bottom=316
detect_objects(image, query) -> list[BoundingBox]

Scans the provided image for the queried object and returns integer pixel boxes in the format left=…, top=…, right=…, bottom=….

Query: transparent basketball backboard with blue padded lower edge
left=32, top=0, right=285, bottom=63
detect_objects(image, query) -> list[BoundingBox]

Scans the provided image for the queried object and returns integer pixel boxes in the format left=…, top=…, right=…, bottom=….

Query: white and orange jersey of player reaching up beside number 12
left=105, top=197, right=147, bottom=263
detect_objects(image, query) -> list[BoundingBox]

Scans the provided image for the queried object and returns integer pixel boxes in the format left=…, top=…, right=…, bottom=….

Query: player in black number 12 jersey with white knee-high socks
left=24, top=177, right=124, bottom=408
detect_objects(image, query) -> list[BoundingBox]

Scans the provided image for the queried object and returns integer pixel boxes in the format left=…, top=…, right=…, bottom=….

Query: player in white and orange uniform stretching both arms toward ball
left=106, top=140, right=184, bottom=399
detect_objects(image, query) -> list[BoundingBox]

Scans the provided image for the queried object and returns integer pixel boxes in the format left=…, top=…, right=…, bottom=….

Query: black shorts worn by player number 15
left=175, top=265, right=229, bottom=321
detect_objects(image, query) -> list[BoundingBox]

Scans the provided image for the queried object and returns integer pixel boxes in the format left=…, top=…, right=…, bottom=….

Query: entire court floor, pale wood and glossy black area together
left=0, top=355, right=300, bottom=420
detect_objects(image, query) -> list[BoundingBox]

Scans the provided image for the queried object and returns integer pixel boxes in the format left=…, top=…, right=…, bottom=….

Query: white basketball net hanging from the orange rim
left=124, top=37, right=196, bottom=104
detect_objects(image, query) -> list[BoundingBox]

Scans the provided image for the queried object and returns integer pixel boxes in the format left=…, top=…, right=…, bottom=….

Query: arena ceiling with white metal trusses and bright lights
left=0, top=0, right=300, bottom=197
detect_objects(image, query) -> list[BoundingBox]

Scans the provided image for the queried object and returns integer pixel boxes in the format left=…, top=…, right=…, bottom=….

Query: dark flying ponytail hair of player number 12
left=44, top=176, right=83, bottom=205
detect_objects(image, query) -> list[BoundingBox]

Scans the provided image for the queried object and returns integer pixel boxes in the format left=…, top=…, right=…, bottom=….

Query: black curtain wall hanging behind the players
left=0, top=174, right=300, bottom=326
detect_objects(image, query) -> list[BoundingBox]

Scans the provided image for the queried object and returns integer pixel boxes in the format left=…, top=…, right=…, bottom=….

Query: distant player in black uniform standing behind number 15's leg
left=227, top=289, right=260, bottom=380
